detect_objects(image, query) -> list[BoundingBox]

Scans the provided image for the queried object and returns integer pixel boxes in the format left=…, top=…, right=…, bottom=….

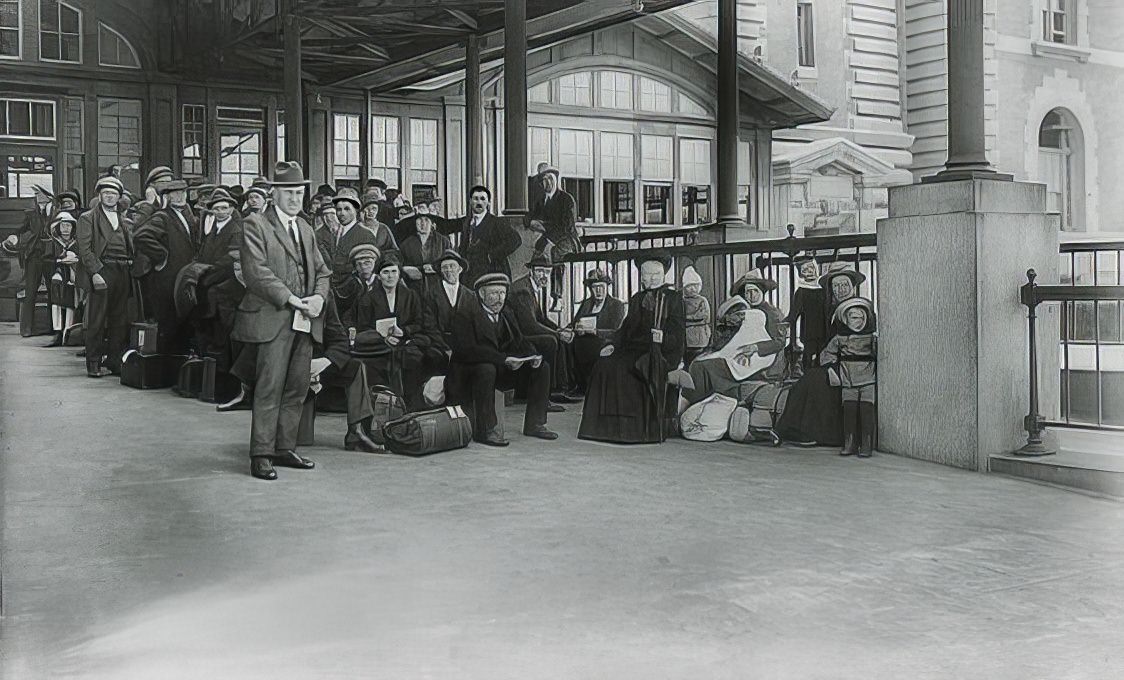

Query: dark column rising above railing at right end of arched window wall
left=717, top=0, right=744, bottom=224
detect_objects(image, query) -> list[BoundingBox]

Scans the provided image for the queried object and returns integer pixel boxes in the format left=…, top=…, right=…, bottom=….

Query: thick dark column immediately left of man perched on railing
left=504, top=0, right=527, bottom=215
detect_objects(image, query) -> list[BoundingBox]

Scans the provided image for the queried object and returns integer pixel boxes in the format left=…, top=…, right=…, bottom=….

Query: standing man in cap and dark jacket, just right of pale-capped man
left=133, top=175, right=200, bottom=354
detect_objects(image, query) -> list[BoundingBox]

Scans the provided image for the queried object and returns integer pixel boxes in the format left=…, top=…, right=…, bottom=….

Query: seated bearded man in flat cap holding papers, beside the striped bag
left=446, top=273, right=558, bottom=446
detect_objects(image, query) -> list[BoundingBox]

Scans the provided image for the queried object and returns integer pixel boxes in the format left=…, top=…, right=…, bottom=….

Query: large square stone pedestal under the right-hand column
left=878, top=179, right=1059, bottom=470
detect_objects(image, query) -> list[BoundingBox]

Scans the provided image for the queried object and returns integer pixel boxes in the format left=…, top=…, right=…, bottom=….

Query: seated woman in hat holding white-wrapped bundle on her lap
left=683, top=272, right=786, bottom=404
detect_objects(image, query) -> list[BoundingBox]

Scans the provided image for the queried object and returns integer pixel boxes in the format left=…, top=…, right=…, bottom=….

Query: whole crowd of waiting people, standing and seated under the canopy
left=3, top=157, right=877, bottom=480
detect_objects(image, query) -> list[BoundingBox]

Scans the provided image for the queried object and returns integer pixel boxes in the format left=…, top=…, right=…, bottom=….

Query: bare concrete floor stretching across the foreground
left=0, top=325, right=1124, bottom=680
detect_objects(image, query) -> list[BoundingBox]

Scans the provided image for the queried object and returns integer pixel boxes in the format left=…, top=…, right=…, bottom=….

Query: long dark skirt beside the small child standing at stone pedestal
left=776, top=366, right=843, bottom=446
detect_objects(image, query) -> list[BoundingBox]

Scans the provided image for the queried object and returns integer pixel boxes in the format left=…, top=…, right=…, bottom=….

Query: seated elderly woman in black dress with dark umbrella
left=578, top=251, right=687, bottom=444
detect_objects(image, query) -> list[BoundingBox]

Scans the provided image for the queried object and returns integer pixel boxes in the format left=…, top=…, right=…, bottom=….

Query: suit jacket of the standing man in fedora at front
left=230, top=208, right=332, bottom=343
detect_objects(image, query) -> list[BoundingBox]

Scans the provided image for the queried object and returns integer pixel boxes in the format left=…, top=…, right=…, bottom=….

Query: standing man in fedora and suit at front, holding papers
left=232, top=162, right=332, bottom=480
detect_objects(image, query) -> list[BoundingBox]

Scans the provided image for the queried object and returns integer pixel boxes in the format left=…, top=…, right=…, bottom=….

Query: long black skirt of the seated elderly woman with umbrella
left=578, top=351, right=676, bottom=444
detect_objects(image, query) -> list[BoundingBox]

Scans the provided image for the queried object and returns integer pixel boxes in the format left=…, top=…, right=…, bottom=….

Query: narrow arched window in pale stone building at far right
left=1039, top=108, right=1085, bottom=232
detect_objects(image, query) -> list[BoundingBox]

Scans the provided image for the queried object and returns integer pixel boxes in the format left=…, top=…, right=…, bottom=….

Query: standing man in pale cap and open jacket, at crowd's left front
left=75, top=176, right=133, bottom=378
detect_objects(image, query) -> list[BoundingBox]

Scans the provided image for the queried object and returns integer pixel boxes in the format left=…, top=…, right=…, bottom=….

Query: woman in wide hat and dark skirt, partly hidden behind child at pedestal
left=774, top=262, right=867, bottom=446
